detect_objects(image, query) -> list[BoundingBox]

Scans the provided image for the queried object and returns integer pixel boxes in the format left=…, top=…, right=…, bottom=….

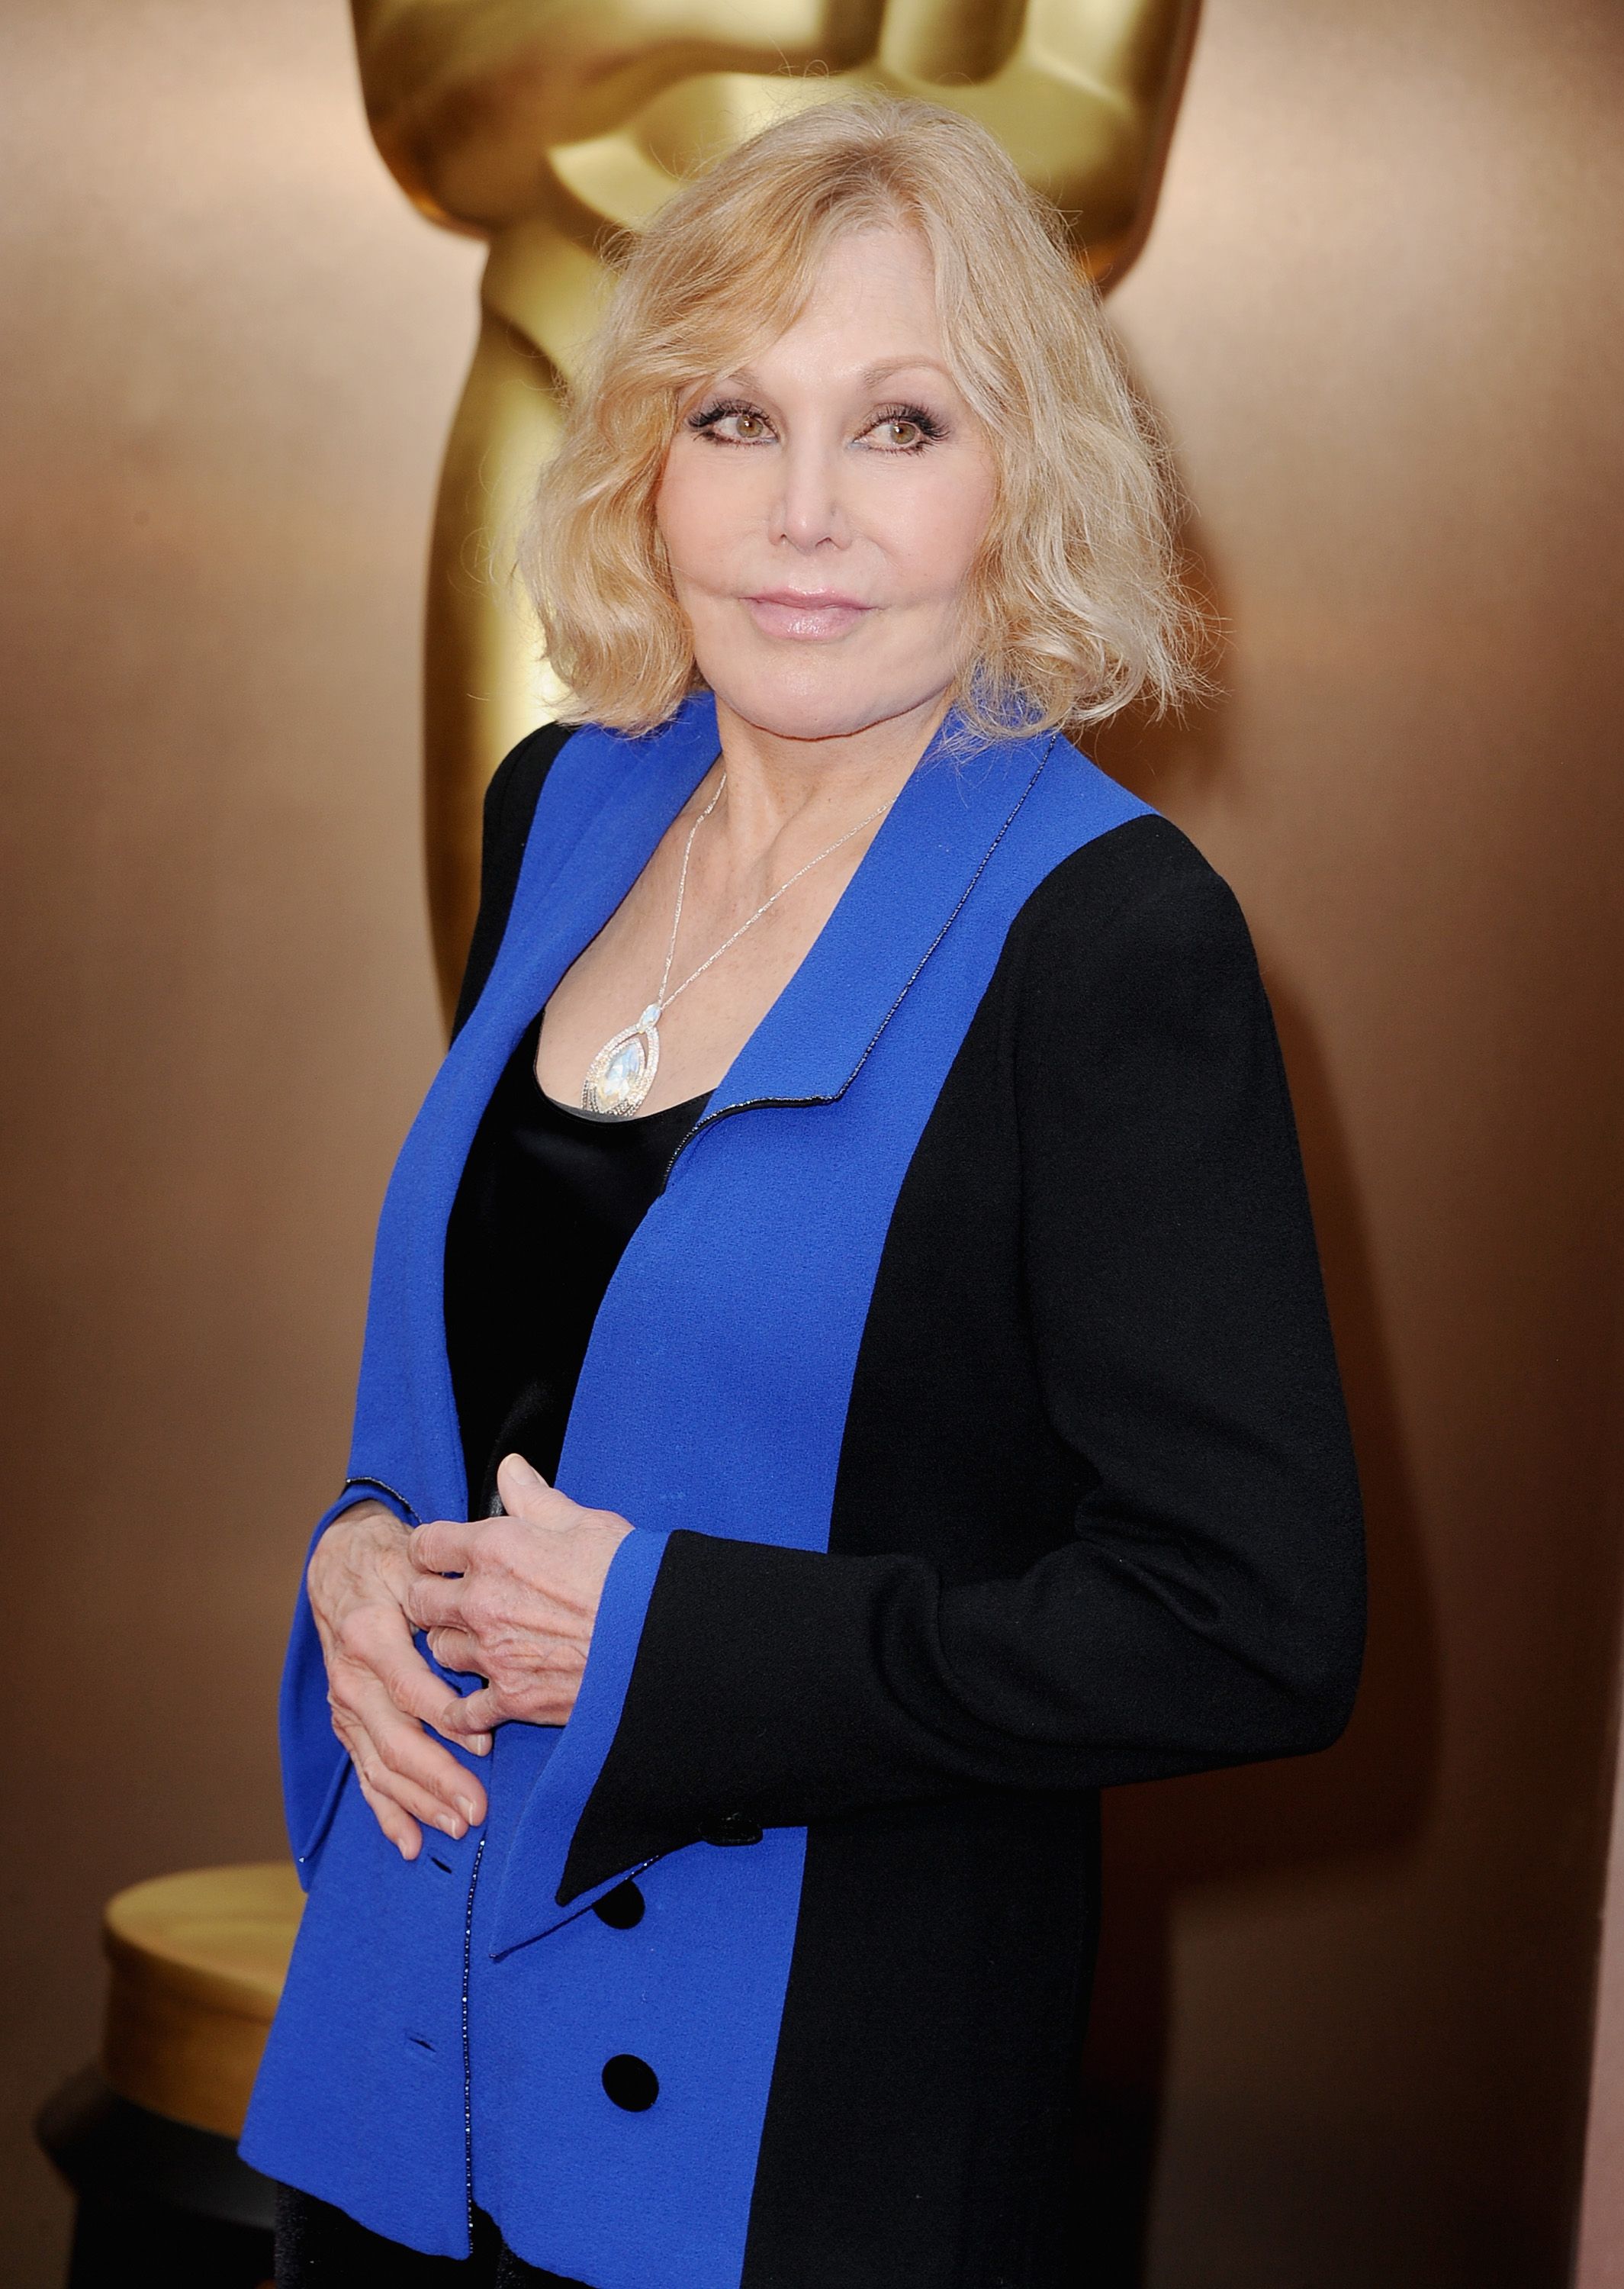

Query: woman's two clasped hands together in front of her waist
left=309, top=1454, right=632, bottom=1859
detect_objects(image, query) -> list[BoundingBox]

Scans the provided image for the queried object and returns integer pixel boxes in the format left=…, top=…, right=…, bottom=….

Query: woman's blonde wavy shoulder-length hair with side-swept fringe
left=519, top=96, right=1203, bottom=737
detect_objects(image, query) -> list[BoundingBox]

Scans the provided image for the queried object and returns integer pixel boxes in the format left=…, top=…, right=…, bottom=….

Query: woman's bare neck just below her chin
left=716, top=691, right=947, bottom=847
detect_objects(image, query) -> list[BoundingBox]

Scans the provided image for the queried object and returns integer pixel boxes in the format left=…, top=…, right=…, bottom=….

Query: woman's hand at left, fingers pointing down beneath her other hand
left=307, top=1502, right=490, bottom=1859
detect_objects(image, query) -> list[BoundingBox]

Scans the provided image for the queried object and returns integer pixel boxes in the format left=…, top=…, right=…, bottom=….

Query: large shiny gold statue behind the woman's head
left=352, top=0, right=1196, bottom=1007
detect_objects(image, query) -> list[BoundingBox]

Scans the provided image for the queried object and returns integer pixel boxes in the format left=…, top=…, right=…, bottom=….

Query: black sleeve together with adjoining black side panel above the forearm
left=561, top=819, right=1363, bottom=1898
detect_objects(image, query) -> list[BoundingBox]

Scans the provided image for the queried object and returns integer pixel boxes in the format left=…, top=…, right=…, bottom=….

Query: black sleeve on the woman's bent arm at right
left=565, top=838, right=1363, bottom=1895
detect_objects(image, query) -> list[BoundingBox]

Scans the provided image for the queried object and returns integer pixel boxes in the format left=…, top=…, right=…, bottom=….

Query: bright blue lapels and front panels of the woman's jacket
left=245, top=700, right=1143, bottom=2289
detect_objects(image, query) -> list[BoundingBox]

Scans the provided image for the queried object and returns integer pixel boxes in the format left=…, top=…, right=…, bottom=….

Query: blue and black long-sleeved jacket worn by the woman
left=243, top=698, right=1363, bottom=2289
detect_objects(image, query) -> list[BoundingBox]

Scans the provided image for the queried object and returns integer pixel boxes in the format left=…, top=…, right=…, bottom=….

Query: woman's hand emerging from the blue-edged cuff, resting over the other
left=405, top=1454, right=632, bottom=1733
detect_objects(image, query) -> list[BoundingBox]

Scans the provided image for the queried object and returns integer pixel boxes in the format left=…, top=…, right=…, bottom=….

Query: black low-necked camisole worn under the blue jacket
left=446, top=1016, right=709, bottom=1518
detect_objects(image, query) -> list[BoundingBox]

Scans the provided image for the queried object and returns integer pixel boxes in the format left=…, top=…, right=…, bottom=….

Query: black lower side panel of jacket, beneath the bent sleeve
left=744, top=1797, right=1098, bottom=2289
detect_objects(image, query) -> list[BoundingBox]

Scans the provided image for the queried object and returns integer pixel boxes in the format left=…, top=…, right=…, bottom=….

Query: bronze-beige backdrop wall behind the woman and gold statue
left=0, top=0, right=1624, bottom=2289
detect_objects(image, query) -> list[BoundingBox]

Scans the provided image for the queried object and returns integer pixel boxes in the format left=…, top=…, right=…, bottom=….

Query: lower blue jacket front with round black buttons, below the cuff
left=469, top=1785, right=806, bottom=2289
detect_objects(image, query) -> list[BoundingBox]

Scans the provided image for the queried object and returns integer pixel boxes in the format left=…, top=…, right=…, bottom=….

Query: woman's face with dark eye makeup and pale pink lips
left=657, top=229, right=995, bottom=739
